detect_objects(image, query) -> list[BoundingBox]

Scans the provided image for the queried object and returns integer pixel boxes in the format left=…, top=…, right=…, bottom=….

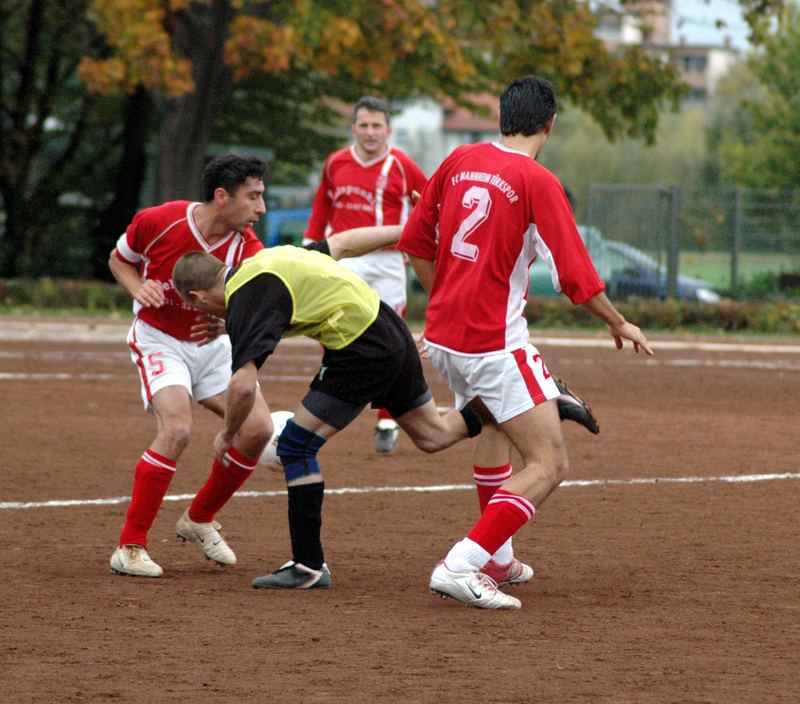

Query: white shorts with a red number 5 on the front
left=128, top=319, right=231, bottom=412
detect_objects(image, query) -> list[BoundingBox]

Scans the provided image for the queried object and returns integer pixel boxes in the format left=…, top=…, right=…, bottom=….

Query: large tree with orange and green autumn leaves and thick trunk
left=82, top=0, right=692, bottom=206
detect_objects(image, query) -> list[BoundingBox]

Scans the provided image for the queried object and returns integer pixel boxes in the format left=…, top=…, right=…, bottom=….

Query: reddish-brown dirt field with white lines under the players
left=0, top=319, right=800, bottom=704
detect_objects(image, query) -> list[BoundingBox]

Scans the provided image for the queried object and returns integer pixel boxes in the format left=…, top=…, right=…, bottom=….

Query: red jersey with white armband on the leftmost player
left=117, top=200, right=264, bottom=340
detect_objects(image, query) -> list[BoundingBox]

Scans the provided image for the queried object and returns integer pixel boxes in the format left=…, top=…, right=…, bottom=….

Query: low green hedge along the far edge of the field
left=0, top=278, right=800, bottom=334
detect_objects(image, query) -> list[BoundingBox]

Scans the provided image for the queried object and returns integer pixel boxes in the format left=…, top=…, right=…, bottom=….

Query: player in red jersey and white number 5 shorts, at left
left=109, top=154, right=272, bottom=577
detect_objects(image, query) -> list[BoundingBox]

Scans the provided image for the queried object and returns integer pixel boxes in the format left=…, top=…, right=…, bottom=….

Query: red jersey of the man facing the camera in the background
left=304, top=146, right=425, bottom=242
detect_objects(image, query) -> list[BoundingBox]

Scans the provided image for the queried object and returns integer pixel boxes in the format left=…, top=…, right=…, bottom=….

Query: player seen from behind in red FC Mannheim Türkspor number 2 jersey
left=399, top=76, right=653, bottom=609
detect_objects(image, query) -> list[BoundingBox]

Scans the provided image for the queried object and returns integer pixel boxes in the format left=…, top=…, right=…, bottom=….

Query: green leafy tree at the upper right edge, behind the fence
left=719, top=5, right=800, bottom=189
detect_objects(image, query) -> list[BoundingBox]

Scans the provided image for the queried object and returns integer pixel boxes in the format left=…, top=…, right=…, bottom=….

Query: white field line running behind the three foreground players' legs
left=0, top=472, right=800, bottom=510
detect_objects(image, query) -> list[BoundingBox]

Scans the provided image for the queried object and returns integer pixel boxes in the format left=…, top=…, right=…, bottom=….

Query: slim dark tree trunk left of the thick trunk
left=91, top=86, right=153, bottom=280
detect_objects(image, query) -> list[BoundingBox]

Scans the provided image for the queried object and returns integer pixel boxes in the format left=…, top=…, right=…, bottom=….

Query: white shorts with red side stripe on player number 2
left=425, top=342, right=560, bottom=423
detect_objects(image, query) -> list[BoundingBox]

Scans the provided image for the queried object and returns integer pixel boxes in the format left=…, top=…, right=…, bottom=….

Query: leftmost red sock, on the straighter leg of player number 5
left=119, top=449, right=175, bottom=548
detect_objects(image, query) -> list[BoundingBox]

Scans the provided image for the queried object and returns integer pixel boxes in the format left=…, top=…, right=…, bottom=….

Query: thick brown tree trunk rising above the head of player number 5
left=156, top=0, right=234, bottom=202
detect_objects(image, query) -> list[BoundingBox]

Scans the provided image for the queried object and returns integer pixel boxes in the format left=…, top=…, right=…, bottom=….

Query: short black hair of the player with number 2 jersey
left=500, top=76, right=558, bottom=137
